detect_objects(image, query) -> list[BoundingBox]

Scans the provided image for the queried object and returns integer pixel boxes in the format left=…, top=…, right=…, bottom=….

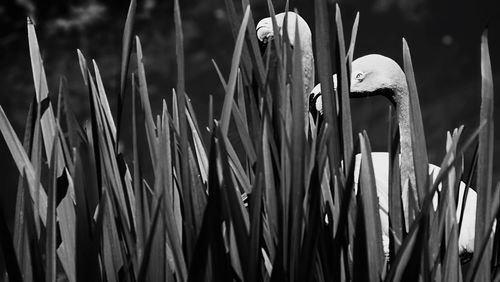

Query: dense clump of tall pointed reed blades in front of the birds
left=0, top=0, right=500, bottom=281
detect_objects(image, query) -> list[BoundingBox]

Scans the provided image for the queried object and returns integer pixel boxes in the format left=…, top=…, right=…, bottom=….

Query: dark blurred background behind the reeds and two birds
left=0, top=0, right=500, bottom=220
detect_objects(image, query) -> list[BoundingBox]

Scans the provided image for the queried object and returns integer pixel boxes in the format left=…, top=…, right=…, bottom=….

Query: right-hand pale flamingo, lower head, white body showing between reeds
left=311, top=54, right=477, bottom=256
